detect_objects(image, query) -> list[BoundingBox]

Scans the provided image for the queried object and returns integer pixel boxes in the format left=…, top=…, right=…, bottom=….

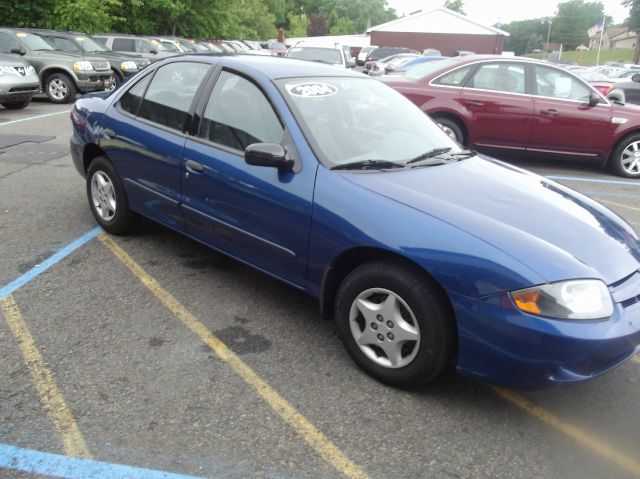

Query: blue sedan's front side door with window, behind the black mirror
left=183, top=70, right=317, bottom=287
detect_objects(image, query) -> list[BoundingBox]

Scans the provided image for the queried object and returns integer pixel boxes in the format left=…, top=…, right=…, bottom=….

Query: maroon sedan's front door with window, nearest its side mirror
left=528, top=64, right=616, bottom=157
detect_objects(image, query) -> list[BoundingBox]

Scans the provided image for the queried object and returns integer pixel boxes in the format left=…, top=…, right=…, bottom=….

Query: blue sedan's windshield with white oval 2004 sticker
left=276, top=77, right=460, bottom=167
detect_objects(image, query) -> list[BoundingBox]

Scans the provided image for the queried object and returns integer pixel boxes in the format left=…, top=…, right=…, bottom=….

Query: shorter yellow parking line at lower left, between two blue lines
left=0, top=295, right=92, bottom=459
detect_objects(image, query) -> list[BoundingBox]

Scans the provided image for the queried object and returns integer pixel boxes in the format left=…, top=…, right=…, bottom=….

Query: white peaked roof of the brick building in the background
left=367, top=7, right=509, bottom=37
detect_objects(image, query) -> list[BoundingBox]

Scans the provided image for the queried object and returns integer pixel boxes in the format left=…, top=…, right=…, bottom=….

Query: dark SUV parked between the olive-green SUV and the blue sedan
left=30, top=30, right=149, bottom=88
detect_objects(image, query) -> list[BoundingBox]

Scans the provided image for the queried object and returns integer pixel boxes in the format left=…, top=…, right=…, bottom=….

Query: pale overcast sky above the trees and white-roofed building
left=387, top=0, right=627, bottom=25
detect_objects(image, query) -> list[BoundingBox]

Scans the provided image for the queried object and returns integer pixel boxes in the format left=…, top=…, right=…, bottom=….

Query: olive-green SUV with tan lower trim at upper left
left=0, top=28, right=113, bottom=103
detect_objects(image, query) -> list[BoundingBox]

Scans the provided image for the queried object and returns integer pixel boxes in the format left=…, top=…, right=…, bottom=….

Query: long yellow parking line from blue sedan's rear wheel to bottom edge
left=98, top=233, right=368, bottom=479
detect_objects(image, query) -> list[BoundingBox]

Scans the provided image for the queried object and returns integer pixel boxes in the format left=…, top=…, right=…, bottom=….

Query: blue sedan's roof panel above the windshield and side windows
left=158, top=52, right=368, bottom=80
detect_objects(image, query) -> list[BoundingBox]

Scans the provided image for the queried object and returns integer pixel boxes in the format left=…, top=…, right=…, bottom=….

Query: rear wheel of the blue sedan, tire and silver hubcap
left=87, top=156, right=139, bottom=235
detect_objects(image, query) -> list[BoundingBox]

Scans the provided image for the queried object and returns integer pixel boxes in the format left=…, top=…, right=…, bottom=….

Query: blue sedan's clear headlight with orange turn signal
left=511, top=279, right=613, bottom=319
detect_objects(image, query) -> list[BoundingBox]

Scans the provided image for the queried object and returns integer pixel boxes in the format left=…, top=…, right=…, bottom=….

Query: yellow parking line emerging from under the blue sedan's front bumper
left=491, top=386, right=640, bottom=477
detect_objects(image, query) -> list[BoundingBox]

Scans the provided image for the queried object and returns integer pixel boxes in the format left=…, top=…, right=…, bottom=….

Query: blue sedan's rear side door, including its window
left=100, top=61, right=211, bottom=229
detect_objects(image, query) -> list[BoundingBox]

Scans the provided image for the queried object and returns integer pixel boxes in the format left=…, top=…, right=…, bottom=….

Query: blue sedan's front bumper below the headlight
left=452, top=275, right=640, bottom=389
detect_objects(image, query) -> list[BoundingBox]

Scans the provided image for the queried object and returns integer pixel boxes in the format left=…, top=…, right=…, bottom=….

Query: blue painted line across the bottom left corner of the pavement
left=0, top=444, right=202, bottom=479
